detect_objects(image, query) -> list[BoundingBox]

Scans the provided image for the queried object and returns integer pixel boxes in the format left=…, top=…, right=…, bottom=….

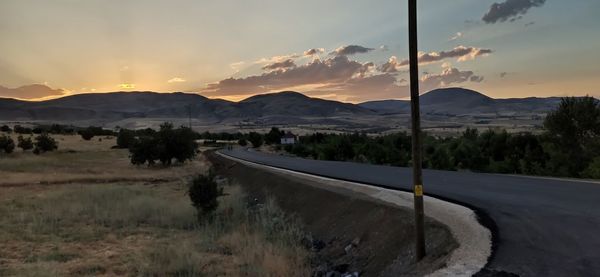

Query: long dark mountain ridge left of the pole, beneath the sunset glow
left=0, top=91, right=374, bottom=122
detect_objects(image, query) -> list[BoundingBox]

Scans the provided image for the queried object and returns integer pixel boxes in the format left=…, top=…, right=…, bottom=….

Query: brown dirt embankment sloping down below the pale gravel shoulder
left=207, top=153, right=457, bottom=276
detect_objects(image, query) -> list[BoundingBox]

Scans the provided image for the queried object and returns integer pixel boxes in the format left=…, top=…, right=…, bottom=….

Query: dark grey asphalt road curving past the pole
left=221, top=149, right=600, bottom=276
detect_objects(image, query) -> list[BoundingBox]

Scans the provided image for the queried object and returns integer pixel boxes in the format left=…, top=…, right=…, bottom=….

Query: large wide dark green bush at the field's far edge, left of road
left=129, top=123, right=198, bottom=166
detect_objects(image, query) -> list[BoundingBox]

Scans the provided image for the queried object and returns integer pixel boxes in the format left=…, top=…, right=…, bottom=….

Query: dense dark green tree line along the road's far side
left=284, top=97, right=600, bottom=178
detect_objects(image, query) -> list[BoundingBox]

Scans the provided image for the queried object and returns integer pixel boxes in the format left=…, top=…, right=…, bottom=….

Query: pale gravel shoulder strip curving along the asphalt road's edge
left=216, top=152, right=492, bottom=276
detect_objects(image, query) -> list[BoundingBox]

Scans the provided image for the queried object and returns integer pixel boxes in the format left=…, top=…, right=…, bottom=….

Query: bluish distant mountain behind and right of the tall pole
left=358, top=88, right=560, bottom=115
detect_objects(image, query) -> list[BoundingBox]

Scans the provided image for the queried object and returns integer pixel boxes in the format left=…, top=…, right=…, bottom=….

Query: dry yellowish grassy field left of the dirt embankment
left=0, top=133, right=310, bottom=276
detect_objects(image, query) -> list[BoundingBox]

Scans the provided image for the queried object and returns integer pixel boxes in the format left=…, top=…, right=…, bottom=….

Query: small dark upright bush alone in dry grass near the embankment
left=188, top=171, right=223, bottom=217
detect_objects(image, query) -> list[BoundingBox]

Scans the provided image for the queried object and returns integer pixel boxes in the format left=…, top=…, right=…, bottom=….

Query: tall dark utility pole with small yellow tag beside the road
left=408, top=0, right=425, bottom=260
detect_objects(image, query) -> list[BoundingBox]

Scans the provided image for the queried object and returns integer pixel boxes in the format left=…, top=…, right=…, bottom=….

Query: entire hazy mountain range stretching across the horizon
left=0, top=88, right=560, bottom=123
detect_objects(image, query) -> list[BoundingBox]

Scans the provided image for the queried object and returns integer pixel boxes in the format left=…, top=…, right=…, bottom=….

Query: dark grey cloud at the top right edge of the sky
left=482, top=0, right=546, bottom=24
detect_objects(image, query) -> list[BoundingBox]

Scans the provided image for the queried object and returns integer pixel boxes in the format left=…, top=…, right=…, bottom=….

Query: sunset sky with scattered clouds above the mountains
left=0, top=0, right=600, bottom=102
